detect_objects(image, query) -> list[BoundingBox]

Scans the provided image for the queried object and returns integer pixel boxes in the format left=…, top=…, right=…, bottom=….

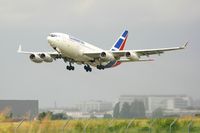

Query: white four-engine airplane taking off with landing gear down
left=17, top=30, right=188, bottom=72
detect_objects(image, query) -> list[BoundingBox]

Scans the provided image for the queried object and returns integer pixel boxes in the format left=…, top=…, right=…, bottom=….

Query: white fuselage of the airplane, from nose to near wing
left=47, top=33, right=103, bottom=66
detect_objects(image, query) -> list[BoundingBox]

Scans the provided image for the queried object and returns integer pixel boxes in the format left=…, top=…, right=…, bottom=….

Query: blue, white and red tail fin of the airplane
left=110, top=30, right=128, bottom=51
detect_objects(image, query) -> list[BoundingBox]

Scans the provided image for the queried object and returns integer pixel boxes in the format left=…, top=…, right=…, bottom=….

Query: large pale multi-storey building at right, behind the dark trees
left=119, top=95, right=192, bottom=114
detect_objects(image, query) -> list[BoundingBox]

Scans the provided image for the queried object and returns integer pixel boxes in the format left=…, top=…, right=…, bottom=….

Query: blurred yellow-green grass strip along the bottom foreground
left=0, top=117, right=200, bottom=133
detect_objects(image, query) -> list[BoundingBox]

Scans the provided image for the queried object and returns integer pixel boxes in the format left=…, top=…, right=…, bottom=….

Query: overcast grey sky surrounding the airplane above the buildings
left=0, top=0, right=200, bottom=107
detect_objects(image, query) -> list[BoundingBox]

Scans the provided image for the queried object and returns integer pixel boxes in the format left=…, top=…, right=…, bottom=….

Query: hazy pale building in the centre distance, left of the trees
left=77, top=100, right=112, bottom=112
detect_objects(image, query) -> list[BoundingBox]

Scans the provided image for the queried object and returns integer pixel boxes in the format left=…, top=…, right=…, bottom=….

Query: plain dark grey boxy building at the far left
left=0, top=100, right=39, bottom=119
